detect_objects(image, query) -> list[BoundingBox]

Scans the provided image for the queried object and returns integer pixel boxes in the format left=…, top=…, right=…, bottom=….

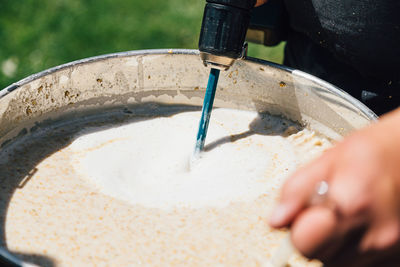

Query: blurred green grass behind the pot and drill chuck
left=0, top=0, right=283, bottom=89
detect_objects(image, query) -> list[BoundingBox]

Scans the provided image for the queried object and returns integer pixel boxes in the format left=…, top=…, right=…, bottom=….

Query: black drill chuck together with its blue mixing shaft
left=194, top=0, right=256, bottom=155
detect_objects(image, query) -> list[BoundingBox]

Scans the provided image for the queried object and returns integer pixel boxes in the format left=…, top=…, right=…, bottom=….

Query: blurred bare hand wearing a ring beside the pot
left=270, top=109, right=400, bottom=266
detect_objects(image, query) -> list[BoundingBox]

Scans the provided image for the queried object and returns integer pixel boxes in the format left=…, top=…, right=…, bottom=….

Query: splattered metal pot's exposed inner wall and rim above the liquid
left=0, top=49, right=377, bottom=266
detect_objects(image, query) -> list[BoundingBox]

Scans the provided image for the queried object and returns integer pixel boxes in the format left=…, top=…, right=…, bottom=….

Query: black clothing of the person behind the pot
left=285, top=0, right=400, bottom=114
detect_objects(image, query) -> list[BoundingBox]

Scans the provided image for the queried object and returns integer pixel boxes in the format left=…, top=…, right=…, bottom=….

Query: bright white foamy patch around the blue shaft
left=69, top=109, right=297, bottom=209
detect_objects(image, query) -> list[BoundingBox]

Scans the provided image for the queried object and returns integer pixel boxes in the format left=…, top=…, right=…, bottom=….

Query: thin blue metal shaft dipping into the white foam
left=194, top=68, right=220, bottom=155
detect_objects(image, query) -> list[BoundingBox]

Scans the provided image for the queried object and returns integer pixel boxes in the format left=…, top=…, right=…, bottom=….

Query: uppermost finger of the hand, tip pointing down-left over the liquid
left=269, top=154, right=333, bottom=228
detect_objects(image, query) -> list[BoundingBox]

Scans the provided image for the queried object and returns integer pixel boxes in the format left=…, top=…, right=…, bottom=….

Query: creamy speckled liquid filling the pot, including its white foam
left=0, top=109, right=330, bottom=266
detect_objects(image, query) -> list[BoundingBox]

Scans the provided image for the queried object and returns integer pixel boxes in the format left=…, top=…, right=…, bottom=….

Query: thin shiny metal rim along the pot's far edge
left=0, top=49, right=378, bottom=120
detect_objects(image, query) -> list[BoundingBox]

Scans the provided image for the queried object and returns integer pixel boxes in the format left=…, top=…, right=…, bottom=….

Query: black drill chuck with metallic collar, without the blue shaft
left=199, top=0, right=256, bottom=70
